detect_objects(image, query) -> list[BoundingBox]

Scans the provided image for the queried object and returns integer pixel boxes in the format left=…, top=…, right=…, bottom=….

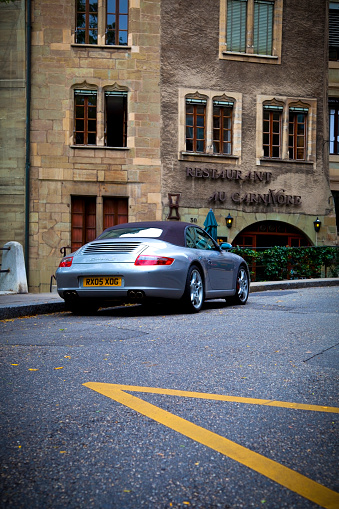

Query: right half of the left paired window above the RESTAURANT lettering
left=213, top=101, right=233, bottom=154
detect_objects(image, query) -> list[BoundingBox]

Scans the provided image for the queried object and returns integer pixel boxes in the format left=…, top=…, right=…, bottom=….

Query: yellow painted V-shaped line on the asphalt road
left=84, top=382, right=339, bottom=509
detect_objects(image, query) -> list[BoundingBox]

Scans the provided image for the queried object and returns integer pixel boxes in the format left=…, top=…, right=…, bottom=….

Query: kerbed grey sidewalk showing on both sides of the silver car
left=0, top=278, right=339, bottom=320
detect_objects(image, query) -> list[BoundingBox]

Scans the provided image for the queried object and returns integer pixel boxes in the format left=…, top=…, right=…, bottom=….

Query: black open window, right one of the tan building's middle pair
left=105, top=91, right=127, bottom=147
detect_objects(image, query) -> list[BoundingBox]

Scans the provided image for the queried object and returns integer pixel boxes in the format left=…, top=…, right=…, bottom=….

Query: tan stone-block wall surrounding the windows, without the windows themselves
left=29, top=0, right=162, bottom=292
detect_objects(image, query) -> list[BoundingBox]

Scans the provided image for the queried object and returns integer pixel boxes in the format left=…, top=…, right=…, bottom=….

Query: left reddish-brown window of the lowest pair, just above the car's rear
left=71, top=196, right=96, bottom=251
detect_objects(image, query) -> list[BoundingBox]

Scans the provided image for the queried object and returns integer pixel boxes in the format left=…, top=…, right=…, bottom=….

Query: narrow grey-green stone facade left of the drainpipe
left=0, top=0, right=26, bottom=250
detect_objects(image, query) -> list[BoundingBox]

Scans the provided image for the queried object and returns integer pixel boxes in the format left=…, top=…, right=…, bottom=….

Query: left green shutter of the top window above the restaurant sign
left=226, top=0, right=247, bottom=53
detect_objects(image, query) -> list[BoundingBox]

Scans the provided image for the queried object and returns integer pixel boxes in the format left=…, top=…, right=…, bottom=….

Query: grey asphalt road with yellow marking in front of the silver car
left=0, top=287, right=339, bottom=509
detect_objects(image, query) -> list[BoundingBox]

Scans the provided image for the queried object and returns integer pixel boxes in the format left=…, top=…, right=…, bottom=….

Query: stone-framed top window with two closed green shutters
left=219, top=0, right=283, bottom=64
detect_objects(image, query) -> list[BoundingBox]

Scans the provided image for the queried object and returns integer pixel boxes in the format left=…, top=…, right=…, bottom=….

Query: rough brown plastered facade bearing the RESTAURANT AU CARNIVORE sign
left=161, top=0, right=337, bottom=247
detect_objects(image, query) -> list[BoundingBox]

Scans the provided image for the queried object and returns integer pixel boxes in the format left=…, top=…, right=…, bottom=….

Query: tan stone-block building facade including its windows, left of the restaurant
left=29, top=0, right=162, bottom=291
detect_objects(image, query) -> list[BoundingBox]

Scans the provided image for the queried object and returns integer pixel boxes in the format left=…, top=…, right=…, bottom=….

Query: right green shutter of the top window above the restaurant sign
left=253, top=0, right=274, bottom=55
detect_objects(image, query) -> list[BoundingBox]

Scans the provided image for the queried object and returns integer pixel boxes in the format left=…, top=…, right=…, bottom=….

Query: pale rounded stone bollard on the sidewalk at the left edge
left=0, top=242, right=28, bottom=293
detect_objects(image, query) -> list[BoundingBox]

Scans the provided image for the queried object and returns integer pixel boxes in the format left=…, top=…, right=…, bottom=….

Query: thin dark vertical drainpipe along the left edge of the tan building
left=25, top=0, right=32, bottom=280
